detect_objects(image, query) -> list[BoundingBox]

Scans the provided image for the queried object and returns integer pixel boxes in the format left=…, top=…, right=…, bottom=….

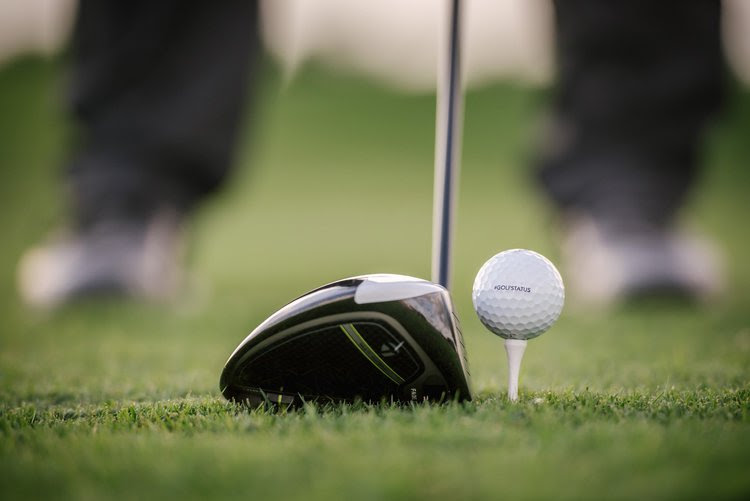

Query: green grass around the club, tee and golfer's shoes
left=0, top=56, right=750, bottom=499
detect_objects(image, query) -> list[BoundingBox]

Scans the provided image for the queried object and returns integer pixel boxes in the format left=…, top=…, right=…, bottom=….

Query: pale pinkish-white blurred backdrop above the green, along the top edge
left=0, top=0, right=750, bottom=86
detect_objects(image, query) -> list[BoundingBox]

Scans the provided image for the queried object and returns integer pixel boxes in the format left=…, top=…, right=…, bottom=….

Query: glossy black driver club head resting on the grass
left=220, top=274, right=471, bottom=406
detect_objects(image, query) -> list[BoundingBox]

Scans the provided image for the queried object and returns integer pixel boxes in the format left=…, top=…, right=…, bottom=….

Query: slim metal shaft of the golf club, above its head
left=432, top=0, right=463, bottom=289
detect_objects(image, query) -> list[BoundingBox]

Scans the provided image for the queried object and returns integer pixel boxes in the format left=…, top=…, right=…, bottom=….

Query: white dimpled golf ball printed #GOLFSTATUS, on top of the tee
left=471, top=249, right=565, bottom=339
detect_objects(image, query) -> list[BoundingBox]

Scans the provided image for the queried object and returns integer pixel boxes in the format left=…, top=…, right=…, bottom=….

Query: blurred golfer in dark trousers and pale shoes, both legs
left=19, top=0, right=724, bottom=307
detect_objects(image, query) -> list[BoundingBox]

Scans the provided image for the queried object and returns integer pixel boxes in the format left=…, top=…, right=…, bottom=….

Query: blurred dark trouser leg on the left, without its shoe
left=67, top=0, right=258, bottom=225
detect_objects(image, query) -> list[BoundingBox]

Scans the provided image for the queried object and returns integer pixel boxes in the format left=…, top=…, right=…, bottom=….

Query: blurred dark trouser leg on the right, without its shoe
left=540, top=0, right=724, bottom=226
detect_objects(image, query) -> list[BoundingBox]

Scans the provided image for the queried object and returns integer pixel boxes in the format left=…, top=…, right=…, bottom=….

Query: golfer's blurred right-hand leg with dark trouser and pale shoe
left=539, top=0, right=724, bottom=303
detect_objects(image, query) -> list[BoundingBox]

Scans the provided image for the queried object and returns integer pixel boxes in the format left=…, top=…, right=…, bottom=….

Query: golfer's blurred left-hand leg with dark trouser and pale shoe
left=18, top=0, right=257, bottom=308
